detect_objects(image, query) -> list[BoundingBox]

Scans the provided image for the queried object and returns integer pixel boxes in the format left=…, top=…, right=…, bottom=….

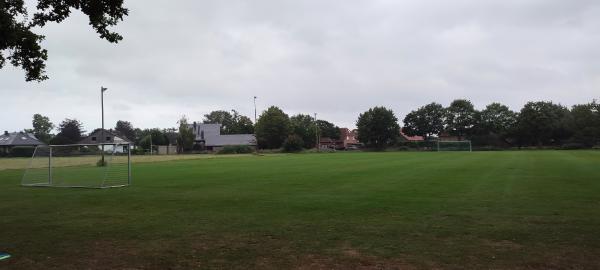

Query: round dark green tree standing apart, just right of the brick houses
left=356, top=107, right=400, bottom=149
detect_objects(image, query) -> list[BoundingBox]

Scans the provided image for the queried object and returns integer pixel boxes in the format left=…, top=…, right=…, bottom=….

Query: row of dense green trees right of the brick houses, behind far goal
left=364, top=99, right=600, bottom=148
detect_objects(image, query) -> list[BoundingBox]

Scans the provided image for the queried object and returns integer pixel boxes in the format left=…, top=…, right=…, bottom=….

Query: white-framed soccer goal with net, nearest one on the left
left=21, top=144, right=131, bottom=188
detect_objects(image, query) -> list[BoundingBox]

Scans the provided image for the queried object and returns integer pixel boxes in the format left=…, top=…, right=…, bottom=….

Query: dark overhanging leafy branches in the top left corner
left=0, top=0, right=128, bottom=81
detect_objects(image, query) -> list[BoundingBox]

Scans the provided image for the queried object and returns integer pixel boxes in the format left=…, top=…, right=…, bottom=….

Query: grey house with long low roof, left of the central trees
left=190, top=122, right=256, bottom=151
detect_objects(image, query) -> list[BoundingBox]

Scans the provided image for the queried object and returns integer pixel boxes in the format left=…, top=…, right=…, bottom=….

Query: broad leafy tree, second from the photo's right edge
left=517, top=101, right=571, bottom=146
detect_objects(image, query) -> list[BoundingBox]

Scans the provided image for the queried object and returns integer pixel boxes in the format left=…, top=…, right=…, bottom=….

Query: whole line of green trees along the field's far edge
left=18, top=99, right=600, bottom=152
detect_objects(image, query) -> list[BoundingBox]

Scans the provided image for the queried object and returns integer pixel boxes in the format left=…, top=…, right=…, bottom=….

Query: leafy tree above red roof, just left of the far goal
left=402, top=102, right=446, bottom=138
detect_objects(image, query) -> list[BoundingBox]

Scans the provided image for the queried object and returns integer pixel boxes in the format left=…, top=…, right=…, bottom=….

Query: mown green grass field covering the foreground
left=0, top=151, right=600, bottom=269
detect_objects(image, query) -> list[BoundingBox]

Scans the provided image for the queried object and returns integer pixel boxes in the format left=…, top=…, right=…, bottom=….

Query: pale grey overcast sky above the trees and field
left=0, top=0, right=600, bottom=131
